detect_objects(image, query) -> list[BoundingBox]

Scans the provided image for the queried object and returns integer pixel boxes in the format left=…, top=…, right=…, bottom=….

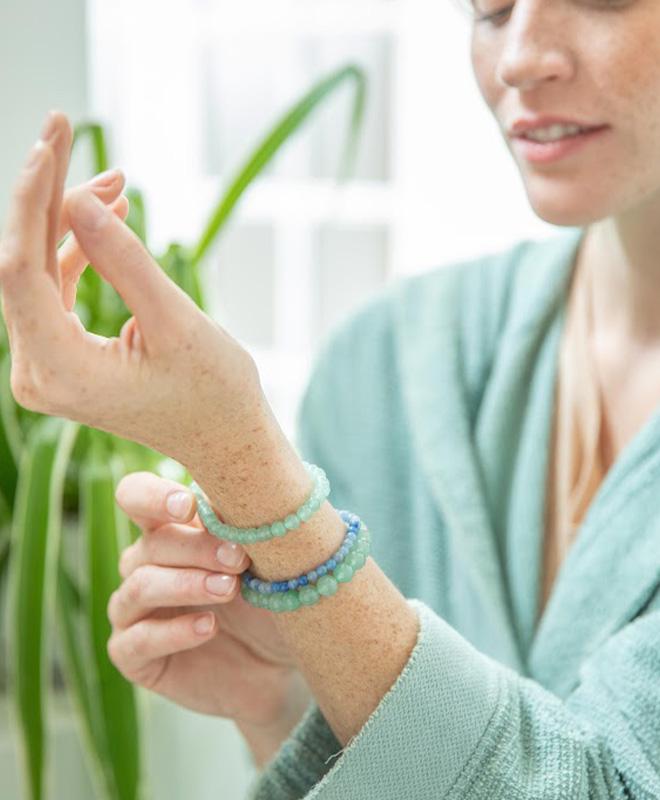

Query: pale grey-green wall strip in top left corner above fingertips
left=0, top=0, right=87, bottom=221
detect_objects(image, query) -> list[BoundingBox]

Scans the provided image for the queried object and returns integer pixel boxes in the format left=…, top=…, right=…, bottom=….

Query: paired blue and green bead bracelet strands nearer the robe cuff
left=241, top=511, right=371, bottom=612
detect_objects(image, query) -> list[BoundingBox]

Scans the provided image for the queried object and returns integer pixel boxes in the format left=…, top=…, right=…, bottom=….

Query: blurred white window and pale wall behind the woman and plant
left=0, top=0, right=556, bottom=800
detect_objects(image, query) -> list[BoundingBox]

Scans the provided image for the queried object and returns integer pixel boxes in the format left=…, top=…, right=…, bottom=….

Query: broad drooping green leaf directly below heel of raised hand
left=7, top=417, right=79, bottom=800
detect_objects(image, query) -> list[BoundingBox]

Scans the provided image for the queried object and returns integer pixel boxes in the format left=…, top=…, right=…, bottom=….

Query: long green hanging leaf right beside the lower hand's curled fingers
left=80, top=431, right=143, bottom=800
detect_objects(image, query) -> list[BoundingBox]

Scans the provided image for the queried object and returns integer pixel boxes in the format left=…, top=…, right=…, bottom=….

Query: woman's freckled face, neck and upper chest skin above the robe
left=470, top=0, right=660, bottom=464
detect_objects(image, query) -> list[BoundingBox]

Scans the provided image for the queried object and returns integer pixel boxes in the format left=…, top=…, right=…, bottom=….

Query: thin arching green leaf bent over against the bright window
left=191, top=64, right=367, bottom=268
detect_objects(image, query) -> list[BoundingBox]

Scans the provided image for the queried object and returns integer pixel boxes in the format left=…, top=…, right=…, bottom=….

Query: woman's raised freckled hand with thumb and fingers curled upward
left=0, top=113, right=270, bottom=467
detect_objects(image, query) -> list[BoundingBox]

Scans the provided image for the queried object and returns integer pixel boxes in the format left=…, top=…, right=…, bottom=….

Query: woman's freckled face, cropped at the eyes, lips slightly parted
left=471, top=0, right=660, bottom=225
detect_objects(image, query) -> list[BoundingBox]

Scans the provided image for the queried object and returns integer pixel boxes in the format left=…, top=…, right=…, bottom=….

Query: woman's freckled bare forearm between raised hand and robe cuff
left=189, top=404, right=418, bottom=747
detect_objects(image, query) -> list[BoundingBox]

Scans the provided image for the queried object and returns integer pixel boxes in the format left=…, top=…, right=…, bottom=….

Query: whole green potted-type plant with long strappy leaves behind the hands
left=0, top=65, right=366, bottom=800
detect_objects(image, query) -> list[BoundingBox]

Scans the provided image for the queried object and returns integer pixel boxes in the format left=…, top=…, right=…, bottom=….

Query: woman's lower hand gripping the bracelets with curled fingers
left=108, top=472, right=310, bottom=738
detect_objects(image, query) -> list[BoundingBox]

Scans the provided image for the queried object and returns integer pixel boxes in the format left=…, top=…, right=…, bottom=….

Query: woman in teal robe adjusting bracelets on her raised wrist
left=0, top=0, right=660, bottom=800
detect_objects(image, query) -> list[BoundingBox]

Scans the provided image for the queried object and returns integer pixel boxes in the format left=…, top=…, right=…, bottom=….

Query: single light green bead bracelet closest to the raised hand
left=190, top=461, right=330, bottom=544
